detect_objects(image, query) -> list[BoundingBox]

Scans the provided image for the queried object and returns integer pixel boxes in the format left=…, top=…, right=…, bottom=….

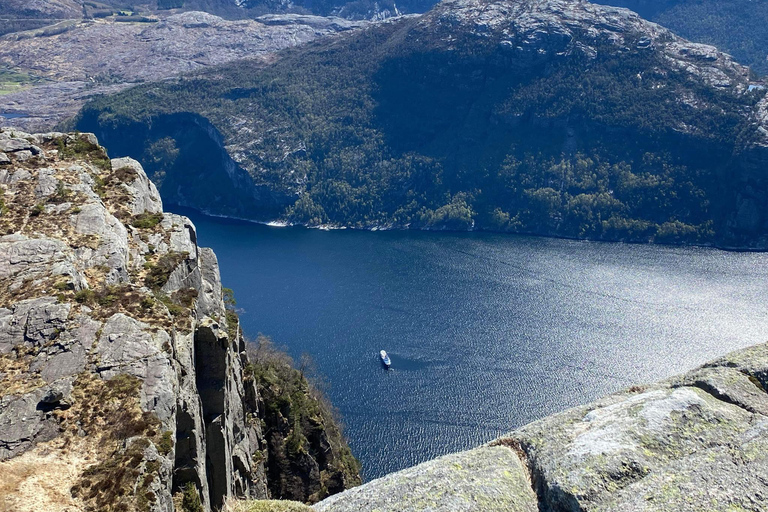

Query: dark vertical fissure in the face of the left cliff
left=195, top=328, right=228, bottom=510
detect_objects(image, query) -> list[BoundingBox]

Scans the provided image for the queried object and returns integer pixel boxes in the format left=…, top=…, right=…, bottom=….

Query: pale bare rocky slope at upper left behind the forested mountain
left=0, top=12, right=363, bottom=131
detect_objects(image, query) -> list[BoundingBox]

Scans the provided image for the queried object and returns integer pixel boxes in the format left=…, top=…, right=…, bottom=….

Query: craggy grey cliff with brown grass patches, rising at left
left=0, top=130, right=359, bottom=512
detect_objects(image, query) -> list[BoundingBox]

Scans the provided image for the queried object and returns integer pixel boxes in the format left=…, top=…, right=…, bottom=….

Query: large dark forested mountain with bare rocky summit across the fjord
left=78, top=0, right=766, bottom=245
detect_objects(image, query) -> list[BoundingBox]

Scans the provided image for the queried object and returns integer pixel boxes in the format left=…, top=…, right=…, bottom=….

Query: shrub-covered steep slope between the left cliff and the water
left=246, top=336, right=360, bottom=502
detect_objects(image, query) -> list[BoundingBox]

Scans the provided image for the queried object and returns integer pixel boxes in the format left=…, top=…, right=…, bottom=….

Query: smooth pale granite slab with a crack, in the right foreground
left=315, top=344, right=768, bottom=512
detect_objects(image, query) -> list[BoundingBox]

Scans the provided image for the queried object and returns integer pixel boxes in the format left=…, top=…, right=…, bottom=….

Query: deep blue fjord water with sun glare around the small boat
left=181, top=210, right=768, bottom=479
